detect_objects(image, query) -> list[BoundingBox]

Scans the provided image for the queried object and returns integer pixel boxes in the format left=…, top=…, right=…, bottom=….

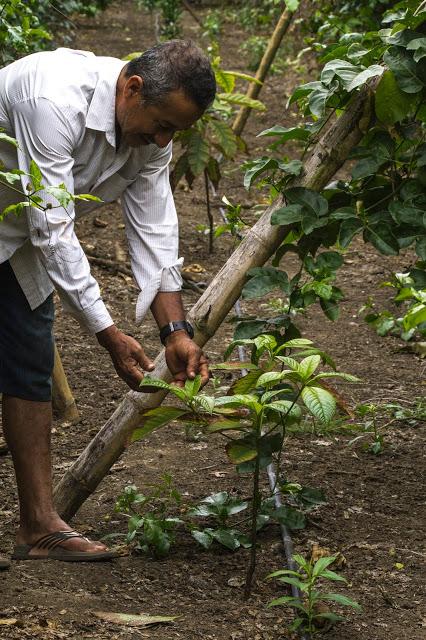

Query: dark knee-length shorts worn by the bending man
left=0, top=262, right=54, bottom=402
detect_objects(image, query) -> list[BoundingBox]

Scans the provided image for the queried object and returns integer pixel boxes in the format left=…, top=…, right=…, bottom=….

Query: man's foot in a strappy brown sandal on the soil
left=12, top=530, right=116, bottom=562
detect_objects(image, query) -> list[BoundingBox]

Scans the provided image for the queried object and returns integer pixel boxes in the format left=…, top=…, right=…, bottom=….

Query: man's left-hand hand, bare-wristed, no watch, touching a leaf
left=96, top=325, right=154, bottom=391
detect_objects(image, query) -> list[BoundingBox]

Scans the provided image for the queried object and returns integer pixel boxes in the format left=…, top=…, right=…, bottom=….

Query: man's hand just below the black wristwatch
left=166, top=331, right=209, bottom=387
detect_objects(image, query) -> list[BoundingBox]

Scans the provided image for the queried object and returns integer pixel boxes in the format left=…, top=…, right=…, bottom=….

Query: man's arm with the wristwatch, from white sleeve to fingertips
left=122, top=145, right=208, bottom=385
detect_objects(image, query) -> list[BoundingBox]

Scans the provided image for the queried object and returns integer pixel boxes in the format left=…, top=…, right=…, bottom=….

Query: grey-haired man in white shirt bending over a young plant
left=0, top=41, right=215, bottom=567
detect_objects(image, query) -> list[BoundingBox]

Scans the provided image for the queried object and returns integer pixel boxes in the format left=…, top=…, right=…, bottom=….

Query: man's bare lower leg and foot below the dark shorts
left=3, top=395, right=106, bottom=555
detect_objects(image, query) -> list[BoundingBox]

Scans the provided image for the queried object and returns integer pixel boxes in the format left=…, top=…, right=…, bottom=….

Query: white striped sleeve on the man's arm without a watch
left=11, top=98, right=113, bottom=333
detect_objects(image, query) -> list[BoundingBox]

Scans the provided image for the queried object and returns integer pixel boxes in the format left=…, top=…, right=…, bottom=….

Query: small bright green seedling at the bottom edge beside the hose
left=267, top=554, right=361, bottom=635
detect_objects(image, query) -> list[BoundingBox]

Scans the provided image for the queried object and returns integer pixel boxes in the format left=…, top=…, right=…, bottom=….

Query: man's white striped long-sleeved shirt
left=0, top=49, right=183, bottom=333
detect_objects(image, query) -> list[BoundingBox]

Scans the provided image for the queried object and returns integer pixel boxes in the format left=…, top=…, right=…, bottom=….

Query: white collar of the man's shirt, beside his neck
left=86, top=58, right=127, bottom=149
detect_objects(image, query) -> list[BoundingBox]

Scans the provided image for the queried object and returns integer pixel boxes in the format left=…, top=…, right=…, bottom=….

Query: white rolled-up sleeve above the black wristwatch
left=122, top=143, right=183, bottom=324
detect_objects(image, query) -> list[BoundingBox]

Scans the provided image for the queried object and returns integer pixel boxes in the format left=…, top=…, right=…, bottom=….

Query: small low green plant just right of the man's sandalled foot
left=113, top=474, right=182, bottom=558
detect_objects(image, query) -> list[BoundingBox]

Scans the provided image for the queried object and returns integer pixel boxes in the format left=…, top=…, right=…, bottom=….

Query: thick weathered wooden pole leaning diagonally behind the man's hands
left=55, top=87, right=373, bottom=519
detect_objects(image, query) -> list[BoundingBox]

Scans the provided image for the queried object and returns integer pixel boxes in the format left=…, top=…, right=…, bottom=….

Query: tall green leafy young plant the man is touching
left=134, top=335, right=356, bottom=597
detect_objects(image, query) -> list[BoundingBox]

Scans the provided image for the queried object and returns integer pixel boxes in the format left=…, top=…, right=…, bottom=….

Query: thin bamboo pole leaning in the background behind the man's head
left=232, top=9, right=293, bottom=136
